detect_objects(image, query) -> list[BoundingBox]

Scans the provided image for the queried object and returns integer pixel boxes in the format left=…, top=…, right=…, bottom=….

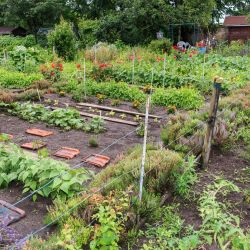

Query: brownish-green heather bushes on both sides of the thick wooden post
left=161, top=86, right=250, bottom=154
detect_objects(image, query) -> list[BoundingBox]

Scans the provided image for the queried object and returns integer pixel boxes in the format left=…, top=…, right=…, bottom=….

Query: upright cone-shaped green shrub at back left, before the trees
left=48, top=19, right=76, bottom=60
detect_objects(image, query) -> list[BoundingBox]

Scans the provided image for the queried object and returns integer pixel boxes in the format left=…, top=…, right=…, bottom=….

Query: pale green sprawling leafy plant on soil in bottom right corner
left=199, top=179, right=249, bottom=250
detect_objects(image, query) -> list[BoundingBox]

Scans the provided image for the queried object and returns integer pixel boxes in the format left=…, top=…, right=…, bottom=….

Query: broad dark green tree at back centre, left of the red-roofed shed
left=94, top=0, right=215, bottom=44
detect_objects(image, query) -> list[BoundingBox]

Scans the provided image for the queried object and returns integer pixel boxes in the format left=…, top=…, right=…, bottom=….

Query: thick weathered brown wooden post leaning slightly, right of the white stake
left=202, top=77, right=223, bottom=168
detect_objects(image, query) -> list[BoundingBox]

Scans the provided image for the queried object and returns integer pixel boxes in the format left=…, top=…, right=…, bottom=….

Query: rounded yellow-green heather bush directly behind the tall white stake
left=91, top=146, right=183, bottom=192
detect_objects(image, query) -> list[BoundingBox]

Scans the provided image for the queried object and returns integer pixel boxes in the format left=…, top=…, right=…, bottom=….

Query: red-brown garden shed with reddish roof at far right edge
left=224, top=16, right=250, bottom=42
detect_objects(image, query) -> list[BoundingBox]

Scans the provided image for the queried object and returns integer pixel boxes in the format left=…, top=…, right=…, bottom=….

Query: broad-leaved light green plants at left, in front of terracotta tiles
left=0, top=144, right=91, bottom=199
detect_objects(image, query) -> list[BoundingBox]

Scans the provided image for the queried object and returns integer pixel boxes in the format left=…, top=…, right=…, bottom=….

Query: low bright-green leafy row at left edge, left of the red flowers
left=0, top=68, right=42, bottom=88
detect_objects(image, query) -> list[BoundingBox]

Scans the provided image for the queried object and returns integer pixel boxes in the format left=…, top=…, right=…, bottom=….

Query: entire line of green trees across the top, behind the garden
left=0, top=0, right=250, bottom=44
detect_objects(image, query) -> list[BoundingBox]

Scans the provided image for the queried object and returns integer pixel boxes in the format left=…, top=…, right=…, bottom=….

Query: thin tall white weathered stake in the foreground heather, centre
left=139, top=94, right=151, bottom=202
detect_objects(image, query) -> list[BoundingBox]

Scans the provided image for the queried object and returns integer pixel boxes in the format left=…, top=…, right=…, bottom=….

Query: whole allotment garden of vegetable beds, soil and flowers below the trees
left=0, top=40, right=250, bottom=250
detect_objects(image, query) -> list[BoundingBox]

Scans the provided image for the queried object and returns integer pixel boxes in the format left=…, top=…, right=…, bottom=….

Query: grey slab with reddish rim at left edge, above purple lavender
left=0, top=200, right=25, bottom=226
